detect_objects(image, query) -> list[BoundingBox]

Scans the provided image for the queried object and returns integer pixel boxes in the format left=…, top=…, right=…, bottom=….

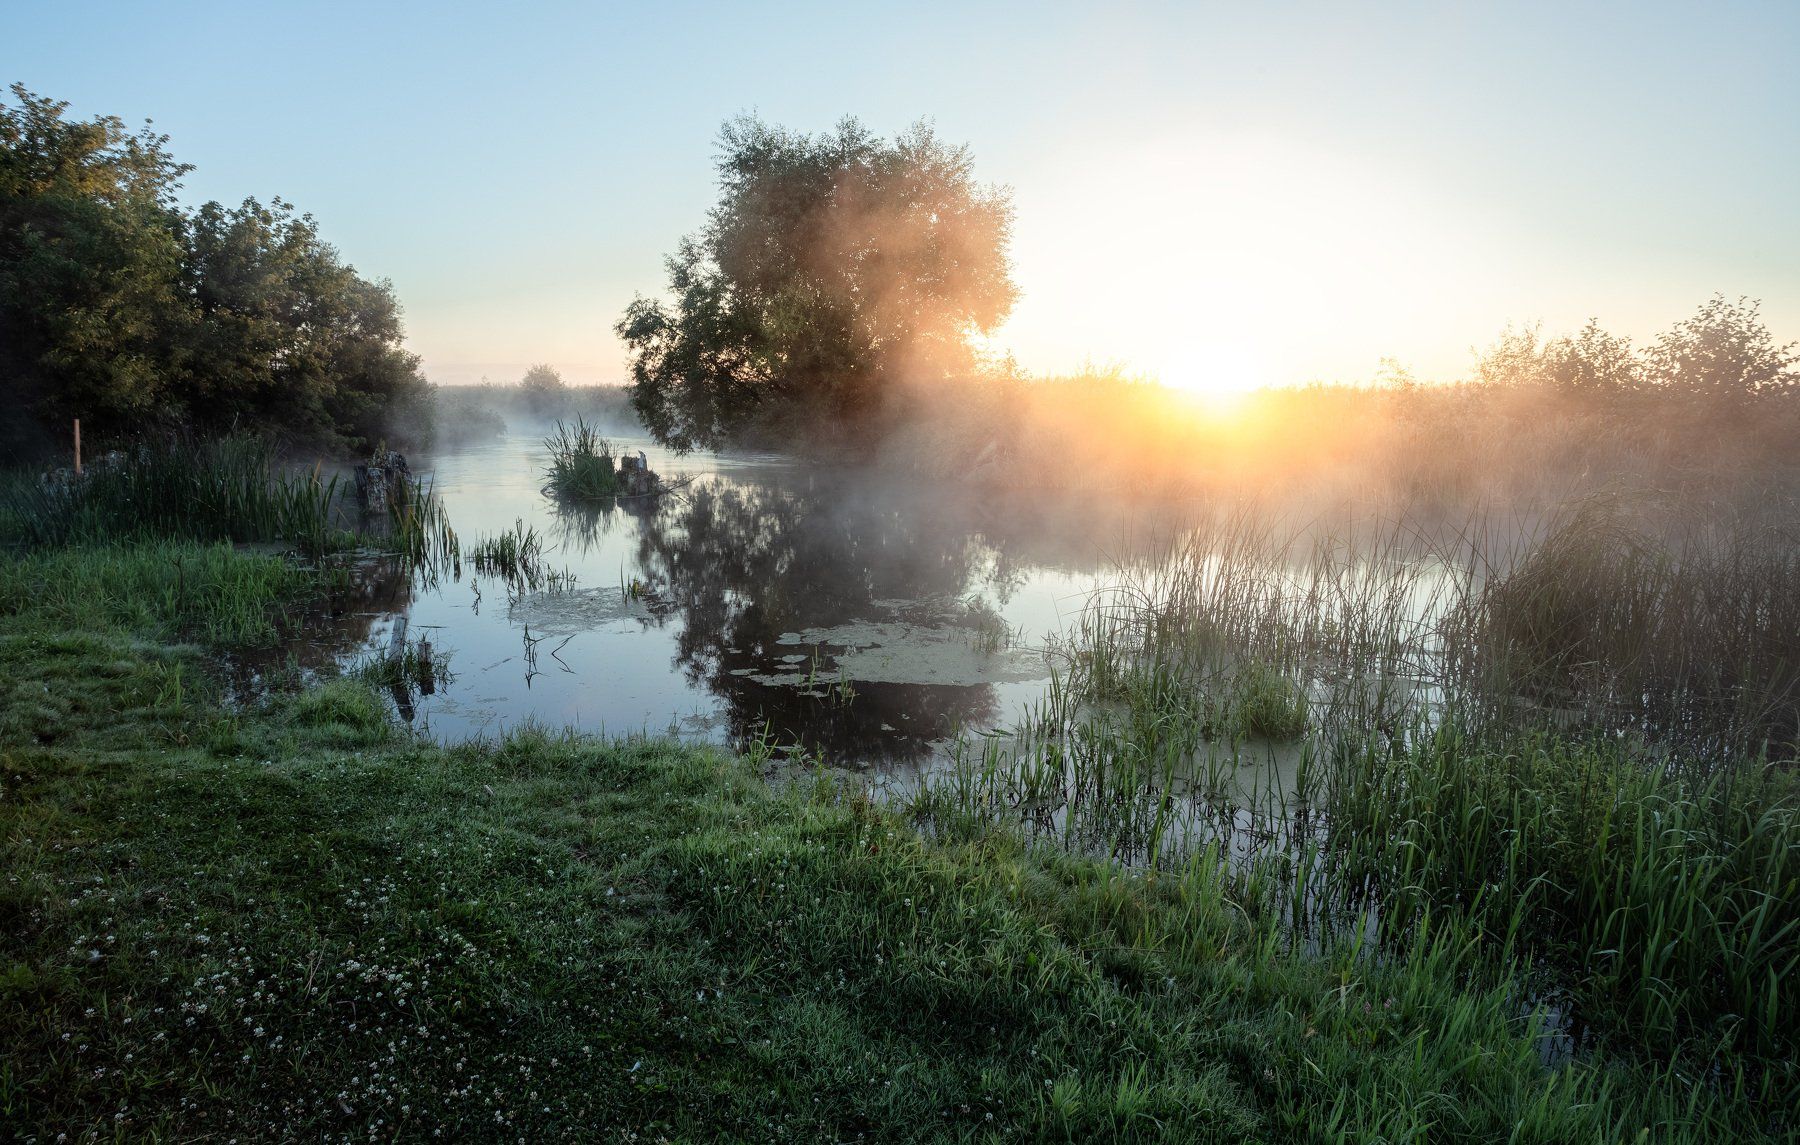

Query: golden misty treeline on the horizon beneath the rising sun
left=880, top=297, right=1800, bottom=500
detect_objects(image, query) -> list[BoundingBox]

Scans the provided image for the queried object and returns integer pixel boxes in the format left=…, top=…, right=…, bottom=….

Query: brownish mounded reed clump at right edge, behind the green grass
left=1444, top=495, right=1800, bottom=760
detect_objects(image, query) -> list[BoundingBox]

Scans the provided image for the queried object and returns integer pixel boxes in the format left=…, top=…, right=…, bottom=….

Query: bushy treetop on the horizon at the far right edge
left=1649, top=293, right=1800, bottom=401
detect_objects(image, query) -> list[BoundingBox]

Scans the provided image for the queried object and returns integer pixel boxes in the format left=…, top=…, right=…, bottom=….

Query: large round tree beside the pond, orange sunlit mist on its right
left=616, top=117, right=1017, bottom=448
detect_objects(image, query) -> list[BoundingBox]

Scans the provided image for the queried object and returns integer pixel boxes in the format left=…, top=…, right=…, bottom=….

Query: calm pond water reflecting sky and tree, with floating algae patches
left=335, top=434, right=1174, bottom=769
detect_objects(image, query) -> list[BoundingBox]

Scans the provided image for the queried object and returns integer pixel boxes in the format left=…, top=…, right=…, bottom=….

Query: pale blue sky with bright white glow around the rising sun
left=14, top=0, right=1800, bottom=389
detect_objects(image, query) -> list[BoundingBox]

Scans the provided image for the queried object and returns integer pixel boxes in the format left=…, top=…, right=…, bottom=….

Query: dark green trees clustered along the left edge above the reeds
left=0, top=85, right=428, bottom=452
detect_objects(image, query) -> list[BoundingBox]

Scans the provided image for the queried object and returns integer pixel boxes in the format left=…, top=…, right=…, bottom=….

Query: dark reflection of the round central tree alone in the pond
left=637, top=482, right=997, bottom=762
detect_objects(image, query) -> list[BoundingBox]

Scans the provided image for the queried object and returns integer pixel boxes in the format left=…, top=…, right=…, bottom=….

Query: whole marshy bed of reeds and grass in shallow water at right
left=907, top=500, right=1800, bottom=1109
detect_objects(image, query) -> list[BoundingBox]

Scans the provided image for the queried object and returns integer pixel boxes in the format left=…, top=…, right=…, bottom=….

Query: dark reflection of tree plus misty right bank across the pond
left=532, top=470, right=1180, bottom=765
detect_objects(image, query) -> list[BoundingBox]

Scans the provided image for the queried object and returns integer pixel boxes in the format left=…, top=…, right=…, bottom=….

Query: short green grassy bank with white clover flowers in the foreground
left=0, top=545, right=1780, bottom=1141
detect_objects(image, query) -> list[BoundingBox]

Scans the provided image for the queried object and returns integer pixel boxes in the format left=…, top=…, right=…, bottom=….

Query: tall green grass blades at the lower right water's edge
left=1325, top=724, right=1800, bottom=1072
